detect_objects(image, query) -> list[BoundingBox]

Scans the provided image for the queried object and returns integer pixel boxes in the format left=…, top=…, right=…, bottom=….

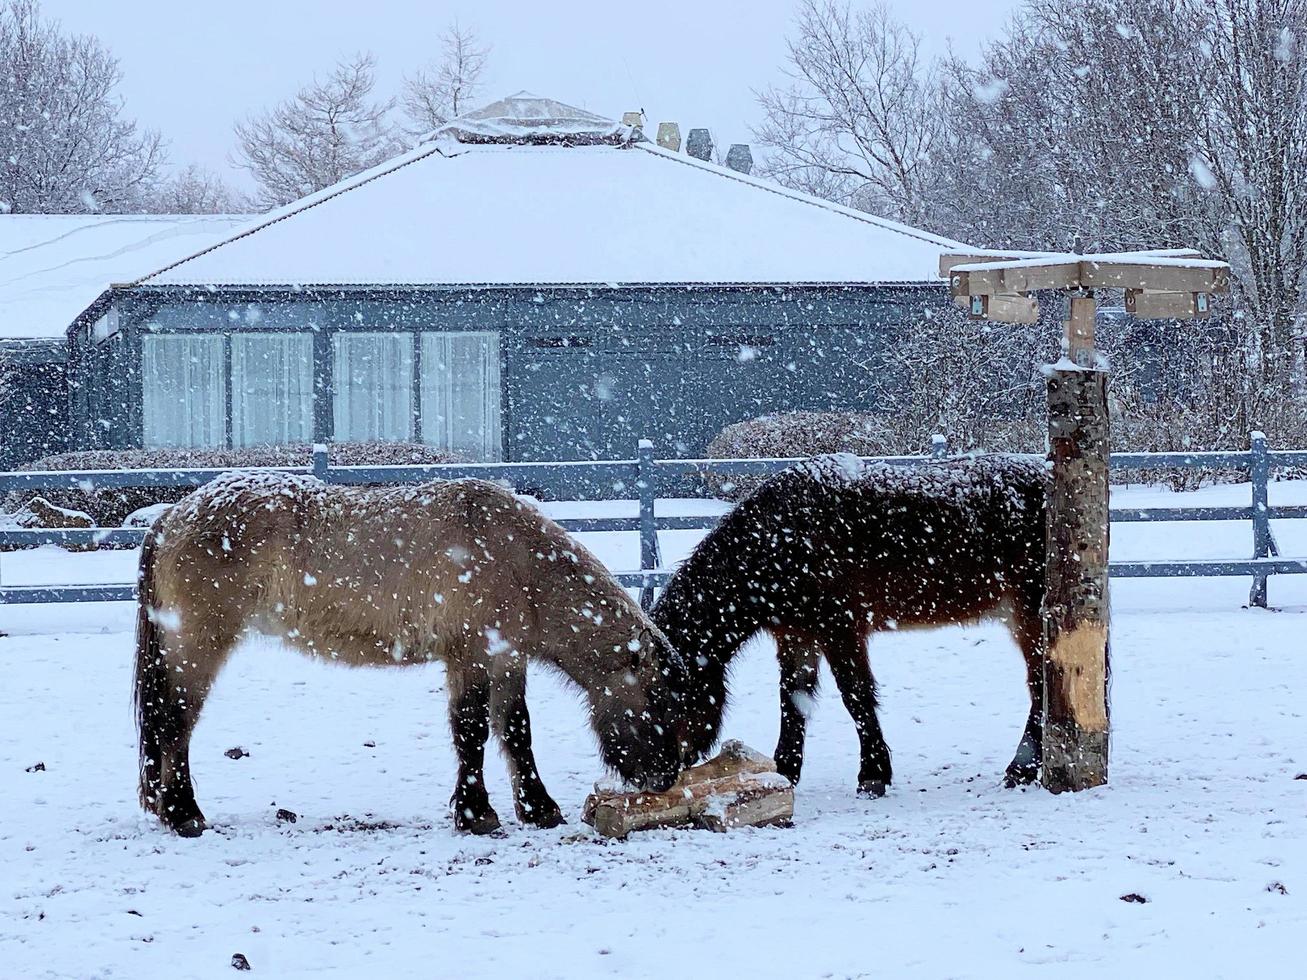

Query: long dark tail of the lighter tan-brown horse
left=132, top=528, right=175, bottom=813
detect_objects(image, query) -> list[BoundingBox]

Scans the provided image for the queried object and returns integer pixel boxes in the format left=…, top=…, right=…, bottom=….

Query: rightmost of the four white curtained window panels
left=422, top=333, right=501, bottom=461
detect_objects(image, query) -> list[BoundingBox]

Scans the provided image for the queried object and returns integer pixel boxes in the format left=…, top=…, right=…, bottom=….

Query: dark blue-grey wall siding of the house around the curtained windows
left=73, top=286, right=948, bottom=460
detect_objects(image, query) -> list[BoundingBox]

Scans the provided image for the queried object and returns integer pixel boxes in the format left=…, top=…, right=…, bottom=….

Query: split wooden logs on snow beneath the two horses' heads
left=582, top=741, right=795, bottom=838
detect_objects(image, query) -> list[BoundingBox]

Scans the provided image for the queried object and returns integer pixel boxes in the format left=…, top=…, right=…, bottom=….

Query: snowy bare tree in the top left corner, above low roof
left=0, top=0, right=162, bottom=213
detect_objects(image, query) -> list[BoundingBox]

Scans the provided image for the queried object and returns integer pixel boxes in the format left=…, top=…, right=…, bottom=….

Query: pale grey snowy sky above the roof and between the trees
left=43, top=0, right=1016, bottom=187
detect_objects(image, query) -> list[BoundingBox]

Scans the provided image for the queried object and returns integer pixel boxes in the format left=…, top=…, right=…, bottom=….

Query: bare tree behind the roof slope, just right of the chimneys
left=754, top=0, right=941, bottom=222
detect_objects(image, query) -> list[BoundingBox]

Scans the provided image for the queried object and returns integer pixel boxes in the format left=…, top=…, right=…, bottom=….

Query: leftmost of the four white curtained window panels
left=141, top=335, right=226, bottom=447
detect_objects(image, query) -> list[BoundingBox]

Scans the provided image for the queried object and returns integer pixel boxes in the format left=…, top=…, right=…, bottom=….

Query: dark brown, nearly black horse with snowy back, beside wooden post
left=652, top=455, right=1047, bottom=796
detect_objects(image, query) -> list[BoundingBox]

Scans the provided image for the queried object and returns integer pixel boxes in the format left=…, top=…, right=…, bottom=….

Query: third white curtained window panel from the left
left=333, top=333, right=413, bottom=442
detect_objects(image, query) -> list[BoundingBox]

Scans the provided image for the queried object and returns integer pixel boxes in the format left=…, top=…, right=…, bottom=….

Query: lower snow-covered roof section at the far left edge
left=0, top=214, right=250, bottom=337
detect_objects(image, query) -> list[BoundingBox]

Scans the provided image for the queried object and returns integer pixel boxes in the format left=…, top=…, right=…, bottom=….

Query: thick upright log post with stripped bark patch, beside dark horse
left=1040, top=297, right=1110, bottom=793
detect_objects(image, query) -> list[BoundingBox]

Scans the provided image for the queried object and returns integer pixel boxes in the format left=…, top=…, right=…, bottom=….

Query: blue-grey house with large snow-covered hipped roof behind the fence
left=0, top=93, right=962, bottom=470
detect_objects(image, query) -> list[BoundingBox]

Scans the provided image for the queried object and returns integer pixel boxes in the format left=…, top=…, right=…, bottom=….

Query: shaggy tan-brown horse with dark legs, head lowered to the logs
left=135, top=472, right=685, bottom=836
